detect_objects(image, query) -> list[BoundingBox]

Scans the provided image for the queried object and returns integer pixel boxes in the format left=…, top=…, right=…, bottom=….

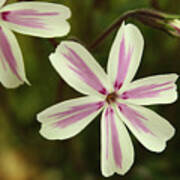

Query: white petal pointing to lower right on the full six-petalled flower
left=115, top=104, right=175, bottom=152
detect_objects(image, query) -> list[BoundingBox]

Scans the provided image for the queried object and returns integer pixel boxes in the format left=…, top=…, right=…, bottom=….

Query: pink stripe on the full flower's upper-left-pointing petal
left=63, top=46, right=108, bottom=95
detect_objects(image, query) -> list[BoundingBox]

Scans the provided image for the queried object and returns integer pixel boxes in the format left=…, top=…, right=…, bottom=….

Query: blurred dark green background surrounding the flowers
left=0, top=0, right=180, bottom=180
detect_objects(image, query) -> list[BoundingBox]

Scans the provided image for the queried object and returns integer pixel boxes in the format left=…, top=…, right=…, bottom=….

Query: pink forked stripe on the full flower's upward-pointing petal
left=114, top=35, right=133, bottom=91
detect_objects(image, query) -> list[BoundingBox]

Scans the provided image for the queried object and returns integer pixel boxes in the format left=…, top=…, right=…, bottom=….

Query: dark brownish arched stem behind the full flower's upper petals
left=89, top=9, right=164, bottom=49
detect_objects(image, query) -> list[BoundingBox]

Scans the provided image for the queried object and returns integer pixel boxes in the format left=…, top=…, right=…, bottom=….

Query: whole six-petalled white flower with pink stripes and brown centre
left=37, top=21, right=178, bottom=177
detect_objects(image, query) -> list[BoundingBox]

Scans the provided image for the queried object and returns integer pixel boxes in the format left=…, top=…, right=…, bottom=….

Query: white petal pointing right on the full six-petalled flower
left=120, top=74, right=178, bottom=105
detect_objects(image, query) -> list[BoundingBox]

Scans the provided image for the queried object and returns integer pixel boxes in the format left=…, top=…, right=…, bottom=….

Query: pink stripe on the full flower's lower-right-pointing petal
left=118, top=103, right=153, bottom=134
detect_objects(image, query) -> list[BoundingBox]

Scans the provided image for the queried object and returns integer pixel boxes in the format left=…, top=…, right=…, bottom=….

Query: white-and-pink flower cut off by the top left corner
left=0, top=0, right=71, bottom=88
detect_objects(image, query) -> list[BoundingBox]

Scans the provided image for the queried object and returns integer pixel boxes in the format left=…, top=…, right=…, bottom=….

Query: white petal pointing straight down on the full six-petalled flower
left=101, top=107, right=134, bottom=177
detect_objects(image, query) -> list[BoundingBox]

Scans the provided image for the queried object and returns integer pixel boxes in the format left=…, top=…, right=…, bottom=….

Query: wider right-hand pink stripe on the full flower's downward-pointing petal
left=109, top=108, right=122, bottom=168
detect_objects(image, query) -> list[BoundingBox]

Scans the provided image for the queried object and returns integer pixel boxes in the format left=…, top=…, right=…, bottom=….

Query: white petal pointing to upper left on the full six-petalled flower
left=50, top=41, right=111, bottom=95
